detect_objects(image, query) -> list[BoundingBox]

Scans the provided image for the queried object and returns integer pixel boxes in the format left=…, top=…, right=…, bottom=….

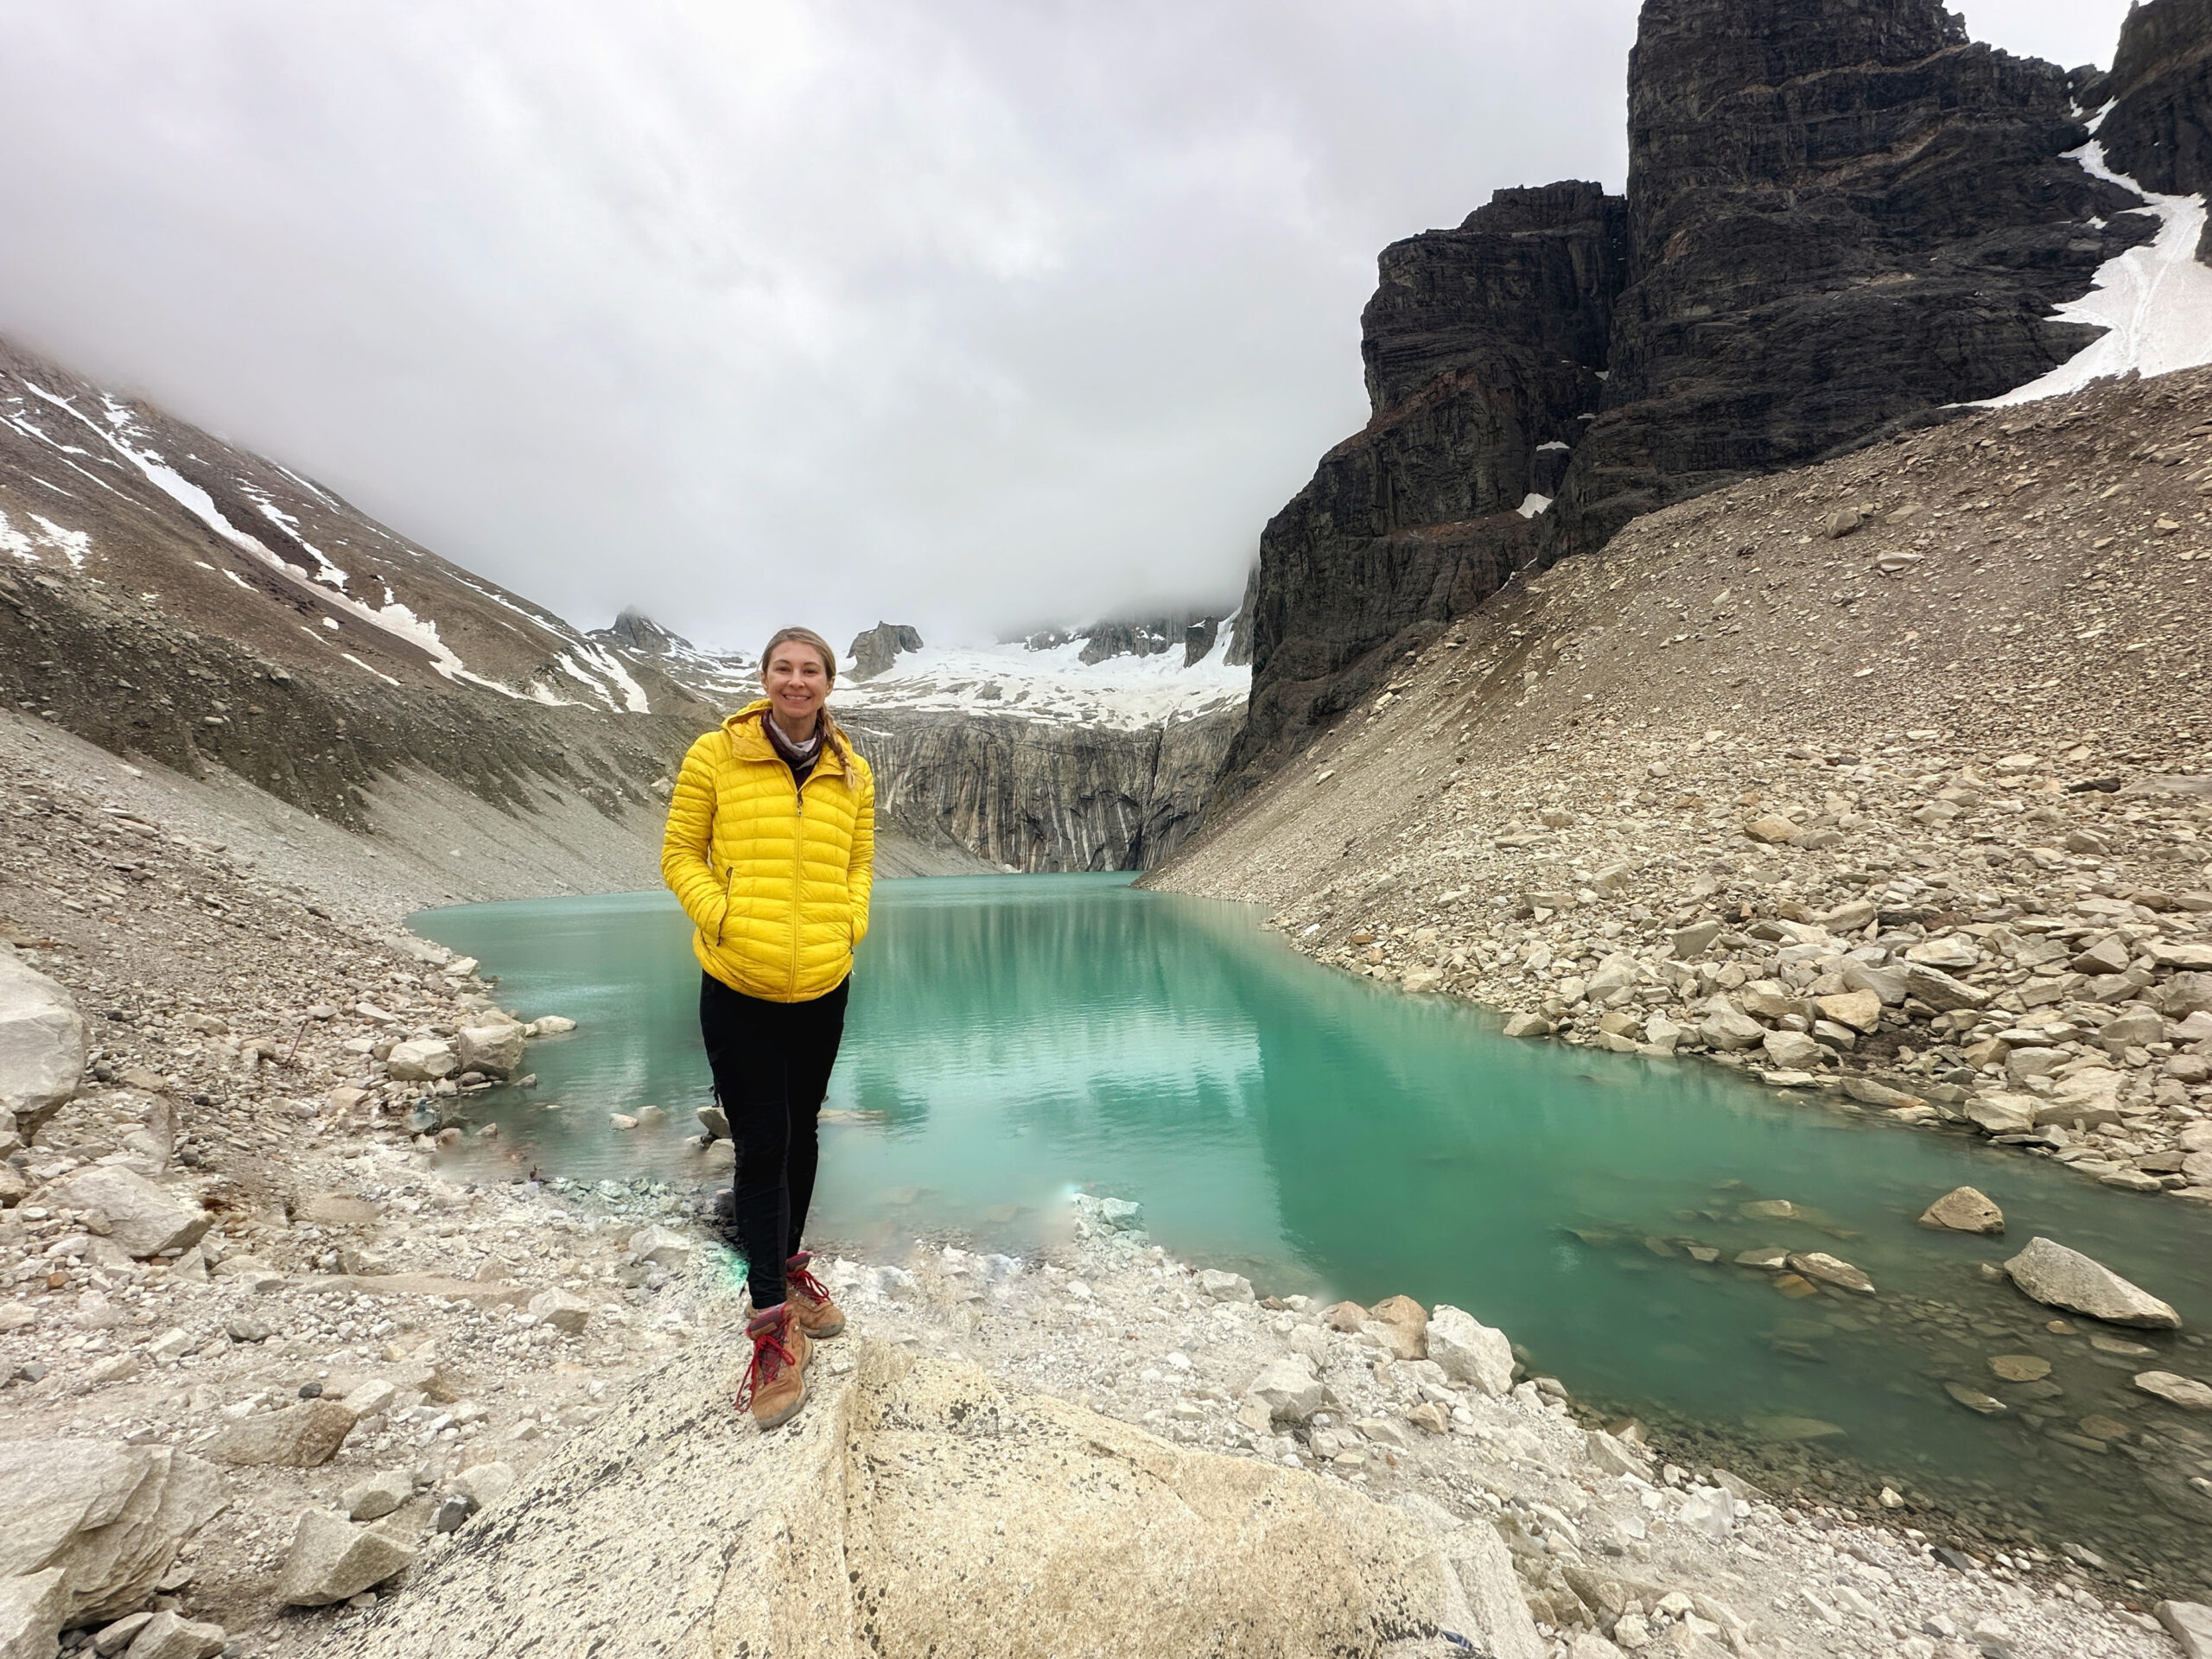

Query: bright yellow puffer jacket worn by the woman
left=661, top=699, right=876, bottom=1002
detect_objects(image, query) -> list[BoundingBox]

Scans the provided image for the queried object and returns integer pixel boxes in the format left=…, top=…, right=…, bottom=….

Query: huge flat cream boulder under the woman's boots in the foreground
left=325, top=1330, right=1533, bottom=1659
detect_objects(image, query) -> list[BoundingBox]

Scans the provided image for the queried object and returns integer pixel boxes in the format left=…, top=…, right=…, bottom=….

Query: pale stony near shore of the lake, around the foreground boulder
left=0, top=708, right=2202, bottom=1659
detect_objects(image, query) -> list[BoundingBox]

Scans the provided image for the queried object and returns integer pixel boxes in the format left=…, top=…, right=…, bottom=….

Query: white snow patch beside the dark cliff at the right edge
left=1980, top=142, right=2212, bottom=410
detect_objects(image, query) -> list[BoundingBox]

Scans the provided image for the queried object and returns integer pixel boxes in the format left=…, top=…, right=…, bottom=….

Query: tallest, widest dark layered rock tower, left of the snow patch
left=1544, top=0, right=2154, bottom=562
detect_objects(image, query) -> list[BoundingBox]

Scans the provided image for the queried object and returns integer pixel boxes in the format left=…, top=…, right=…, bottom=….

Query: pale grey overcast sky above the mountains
left=0, top=0, right=2126, bottom=644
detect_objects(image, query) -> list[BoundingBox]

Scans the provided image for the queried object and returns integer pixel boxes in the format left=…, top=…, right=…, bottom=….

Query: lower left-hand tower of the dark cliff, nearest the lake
left=1224, top=181, right=1626, bottom=794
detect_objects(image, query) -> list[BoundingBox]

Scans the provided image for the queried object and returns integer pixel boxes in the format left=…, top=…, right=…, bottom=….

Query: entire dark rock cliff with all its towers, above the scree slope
left=1217, top=0, right=2185, bottom=805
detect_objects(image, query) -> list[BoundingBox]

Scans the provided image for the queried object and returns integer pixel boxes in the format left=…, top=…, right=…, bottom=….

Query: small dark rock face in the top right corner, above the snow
left=2082, top=0, right=2212, bottom=265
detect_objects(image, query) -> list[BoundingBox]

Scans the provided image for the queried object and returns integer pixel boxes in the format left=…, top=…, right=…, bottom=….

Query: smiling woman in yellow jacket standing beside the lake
left=661, top=628, right=876, bottom=1429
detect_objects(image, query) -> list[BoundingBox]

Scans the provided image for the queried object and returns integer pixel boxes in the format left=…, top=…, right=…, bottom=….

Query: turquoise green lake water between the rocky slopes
left=414, top=876, right=2212, bottom=1595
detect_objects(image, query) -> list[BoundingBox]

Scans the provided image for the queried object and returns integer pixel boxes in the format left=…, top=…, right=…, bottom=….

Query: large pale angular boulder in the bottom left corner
left=0, top=1440, right=224, bottom=1628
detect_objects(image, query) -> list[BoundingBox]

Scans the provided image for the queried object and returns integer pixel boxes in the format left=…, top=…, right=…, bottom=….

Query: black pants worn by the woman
left=699, top=973, right=852, bottom=1310
